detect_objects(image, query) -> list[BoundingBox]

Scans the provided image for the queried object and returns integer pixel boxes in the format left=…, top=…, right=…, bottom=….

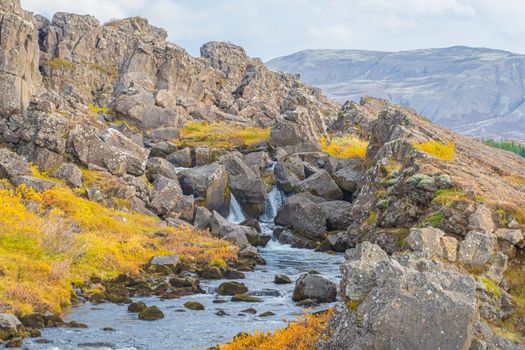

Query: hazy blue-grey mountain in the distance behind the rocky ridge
left=267, top=46, right=525, bottom=140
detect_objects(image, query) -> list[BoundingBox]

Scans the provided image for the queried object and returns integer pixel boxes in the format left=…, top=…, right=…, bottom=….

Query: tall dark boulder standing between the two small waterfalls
left=221, top=153, right=266, bottom=218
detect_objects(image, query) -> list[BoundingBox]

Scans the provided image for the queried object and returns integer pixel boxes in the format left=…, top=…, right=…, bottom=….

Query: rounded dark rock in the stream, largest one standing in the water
left=292, top=273, right=337, bottom=303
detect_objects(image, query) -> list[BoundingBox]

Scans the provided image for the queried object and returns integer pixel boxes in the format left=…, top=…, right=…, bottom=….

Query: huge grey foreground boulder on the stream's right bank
left=318, top=244, right=478, bottom=349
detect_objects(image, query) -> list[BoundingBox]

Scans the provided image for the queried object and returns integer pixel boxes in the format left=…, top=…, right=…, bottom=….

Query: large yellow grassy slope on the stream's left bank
left=0, top=185, right=237, bottom=314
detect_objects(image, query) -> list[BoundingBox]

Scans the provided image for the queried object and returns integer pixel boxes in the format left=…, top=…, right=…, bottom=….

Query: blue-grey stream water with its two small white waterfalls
left=26, top=187, right=343, bottom=350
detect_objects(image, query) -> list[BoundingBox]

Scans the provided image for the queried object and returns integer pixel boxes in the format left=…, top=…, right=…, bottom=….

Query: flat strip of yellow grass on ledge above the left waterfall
left=175, top=122, right=271, bottom=149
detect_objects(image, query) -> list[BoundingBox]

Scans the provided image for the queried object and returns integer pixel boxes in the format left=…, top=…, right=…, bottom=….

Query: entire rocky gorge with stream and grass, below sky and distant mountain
left=0, top=0, right=525, bottom=350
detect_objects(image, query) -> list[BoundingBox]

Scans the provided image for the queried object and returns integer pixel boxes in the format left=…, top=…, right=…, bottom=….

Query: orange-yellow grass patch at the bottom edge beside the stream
left=217, top=310, right=333, bottom=350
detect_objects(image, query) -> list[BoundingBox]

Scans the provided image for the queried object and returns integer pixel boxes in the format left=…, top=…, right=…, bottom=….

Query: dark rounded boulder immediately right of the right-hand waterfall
left=275, top=194, right=327, bottom=240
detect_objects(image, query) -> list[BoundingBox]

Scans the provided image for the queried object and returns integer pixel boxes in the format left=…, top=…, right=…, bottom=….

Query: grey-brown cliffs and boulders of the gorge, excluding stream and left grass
left=0, top=0, right=525, bottom=350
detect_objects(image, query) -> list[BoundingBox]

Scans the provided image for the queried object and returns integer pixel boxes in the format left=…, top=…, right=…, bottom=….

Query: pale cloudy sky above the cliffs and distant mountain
left=21, top=0, right=525, bottom=60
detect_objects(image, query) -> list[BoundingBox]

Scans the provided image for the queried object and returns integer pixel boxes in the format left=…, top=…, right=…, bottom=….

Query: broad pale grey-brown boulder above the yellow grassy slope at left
left=70, top=125, right=149, bottom=176
